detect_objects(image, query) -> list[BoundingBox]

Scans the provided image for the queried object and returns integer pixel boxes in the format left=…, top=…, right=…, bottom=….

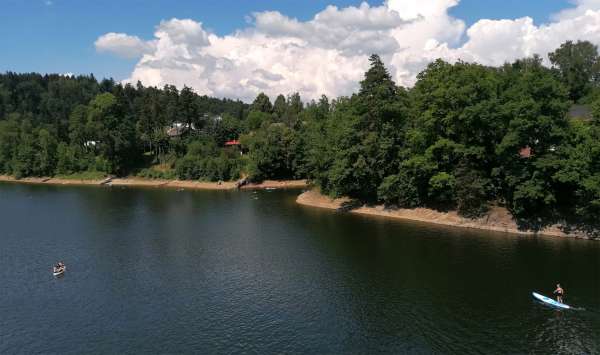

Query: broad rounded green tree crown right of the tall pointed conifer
left=410, top=60, right=506, bottom=160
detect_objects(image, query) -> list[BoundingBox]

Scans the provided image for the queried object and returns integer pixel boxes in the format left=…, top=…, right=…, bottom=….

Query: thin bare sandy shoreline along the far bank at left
left=0, top=175, right=308, bottom=191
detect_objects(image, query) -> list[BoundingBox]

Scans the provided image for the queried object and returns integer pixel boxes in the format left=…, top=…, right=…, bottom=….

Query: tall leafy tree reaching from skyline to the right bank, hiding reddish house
left=494, top=57, right=569, bottom=228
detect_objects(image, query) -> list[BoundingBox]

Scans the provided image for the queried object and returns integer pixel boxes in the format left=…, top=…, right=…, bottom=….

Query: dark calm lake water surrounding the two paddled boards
left=0, top=184, right=600, bottom=354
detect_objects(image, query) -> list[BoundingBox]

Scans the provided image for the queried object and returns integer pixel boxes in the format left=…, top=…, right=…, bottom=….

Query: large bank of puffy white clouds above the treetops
left=95, top=0, right=600, bottom=101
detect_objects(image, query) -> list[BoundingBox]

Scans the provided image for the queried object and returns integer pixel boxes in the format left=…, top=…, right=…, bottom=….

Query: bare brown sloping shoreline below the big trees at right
left=296, top=190, right=600, bottom=240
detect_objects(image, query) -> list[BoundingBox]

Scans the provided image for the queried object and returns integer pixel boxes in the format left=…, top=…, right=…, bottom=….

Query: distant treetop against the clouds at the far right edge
left=548, top=41, right=600, bottom=102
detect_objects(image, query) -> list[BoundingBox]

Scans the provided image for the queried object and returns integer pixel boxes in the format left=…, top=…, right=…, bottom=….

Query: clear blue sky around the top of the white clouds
left=0, top=0, right=571, bottom=79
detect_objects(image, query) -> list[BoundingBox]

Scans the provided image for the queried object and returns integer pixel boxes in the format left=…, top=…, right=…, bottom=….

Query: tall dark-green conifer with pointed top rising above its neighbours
left=308, top=55, right=407, bottom=201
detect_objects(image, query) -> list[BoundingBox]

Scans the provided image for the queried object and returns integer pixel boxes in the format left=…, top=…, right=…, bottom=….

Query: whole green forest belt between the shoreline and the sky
left=0, top=41, right=600, bottom=230
